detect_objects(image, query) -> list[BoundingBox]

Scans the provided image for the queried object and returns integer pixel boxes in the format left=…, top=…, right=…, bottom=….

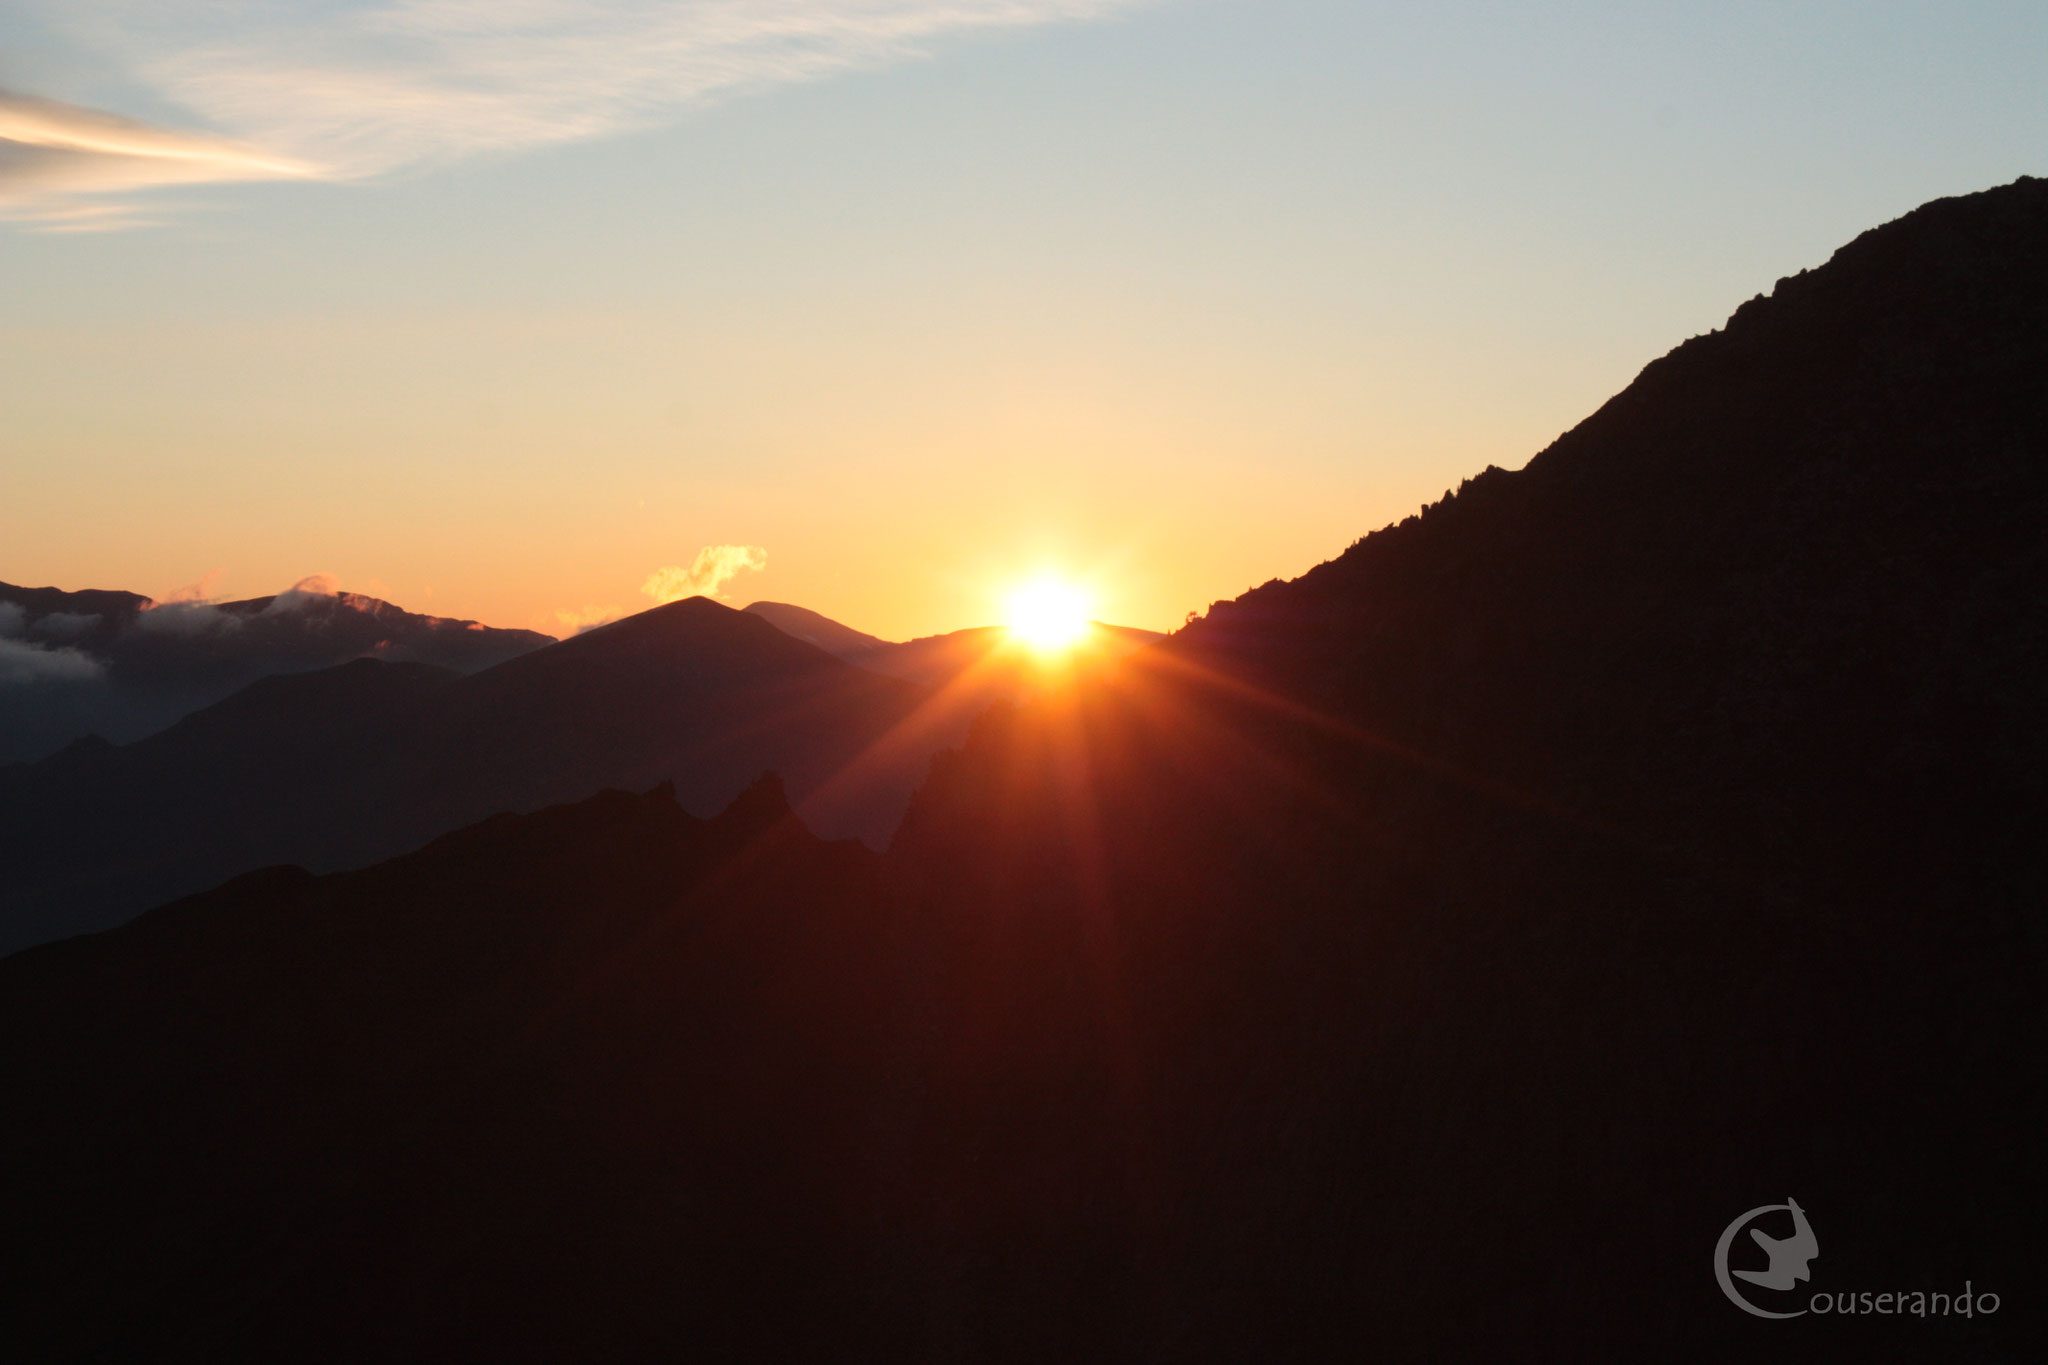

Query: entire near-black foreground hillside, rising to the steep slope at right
left=0, top=182, right=2048, bottom=1361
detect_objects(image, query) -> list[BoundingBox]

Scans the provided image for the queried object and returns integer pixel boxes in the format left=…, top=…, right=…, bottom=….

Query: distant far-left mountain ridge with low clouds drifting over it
left=0, top=583, right=553, bottom=763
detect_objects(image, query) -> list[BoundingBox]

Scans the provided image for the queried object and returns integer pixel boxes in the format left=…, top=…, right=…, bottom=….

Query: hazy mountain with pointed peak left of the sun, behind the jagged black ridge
left=0, top=598, right=929, bottom=950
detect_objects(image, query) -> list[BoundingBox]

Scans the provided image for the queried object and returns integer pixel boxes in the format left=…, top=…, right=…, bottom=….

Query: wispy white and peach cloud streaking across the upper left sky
left=0, top=0, right=1159, bottom=225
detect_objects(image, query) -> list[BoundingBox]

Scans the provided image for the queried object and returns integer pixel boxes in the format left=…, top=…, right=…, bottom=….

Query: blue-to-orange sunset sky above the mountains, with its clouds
left=0, top=0, right=2048, bottom=639
